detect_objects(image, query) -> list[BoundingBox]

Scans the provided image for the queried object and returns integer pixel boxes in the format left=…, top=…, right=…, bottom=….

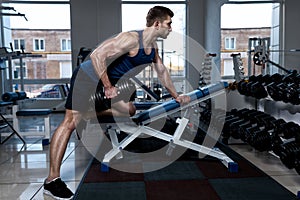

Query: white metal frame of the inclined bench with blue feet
left=95, top=85, right=238, bottom=172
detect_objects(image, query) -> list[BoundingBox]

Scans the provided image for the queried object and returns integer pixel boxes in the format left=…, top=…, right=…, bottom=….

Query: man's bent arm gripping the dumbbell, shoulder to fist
left=90, top=32, right=136, bottom=98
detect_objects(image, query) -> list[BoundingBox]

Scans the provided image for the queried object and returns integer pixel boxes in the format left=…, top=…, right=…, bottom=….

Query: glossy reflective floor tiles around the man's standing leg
left=0, top=114, right=92, bottom=200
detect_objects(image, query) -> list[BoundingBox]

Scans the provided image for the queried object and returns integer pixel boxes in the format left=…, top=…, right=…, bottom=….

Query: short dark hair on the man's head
left=146, top=6, right=174, bottom=27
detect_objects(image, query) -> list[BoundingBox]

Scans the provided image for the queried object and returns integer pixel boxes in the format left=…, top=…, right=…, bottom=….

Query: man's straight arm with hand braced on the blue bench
left=154, top=48, right=190, bottom=103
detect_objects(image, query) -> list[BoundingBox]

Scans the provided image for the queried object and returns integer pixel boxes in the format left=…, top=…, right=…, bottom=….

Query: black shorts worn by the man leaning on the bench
left=65, top=63, right=136, bottom=112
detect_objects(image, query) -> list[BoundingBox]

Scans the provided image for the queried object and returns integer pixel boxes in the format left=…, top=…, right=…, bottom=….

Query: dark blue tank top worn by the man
left=107, top=30, right=155, bottom=80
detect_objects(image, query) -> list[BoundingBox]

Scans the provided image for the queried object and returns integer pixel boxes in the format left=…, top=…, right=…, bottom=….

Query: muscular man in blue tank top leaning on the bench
left=44, top=6, right=190, bottom=199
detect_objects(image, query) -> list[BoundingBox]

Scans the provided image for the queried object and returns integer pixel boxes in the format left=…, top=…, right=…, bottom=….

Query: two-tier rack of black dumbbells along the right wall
left=224, top=72, right=300, bottom=174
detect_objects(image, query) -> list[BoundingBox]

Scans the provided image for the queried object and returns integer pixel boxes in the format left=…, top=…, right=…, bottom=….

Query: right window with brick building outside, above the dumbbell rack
left=220, top=0, right=284, bottom=78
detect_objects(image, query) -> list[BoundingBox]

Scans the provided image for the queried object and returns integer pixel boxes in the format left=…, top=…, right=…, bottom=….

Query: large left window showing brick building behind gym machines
left=0, top=0, right=72, bottom=94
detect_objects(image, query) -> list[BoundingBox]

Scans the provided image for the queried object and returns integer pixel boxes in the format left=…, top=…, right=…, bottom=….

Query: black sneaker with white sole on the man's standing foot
left=44, top=178, right=74, bottom=200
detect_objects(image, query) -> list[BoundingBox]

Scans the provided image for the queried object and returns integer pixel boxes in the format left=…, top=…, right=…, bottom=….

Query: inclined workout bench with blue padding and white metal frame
left=87, top=82, right=238, bottom=172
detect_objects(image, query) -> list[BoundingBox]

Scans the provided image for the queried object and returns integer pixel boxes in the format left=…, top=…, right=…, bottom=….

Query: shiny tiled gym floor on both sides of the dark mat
left=0, top=113, right=300, bottom=200
